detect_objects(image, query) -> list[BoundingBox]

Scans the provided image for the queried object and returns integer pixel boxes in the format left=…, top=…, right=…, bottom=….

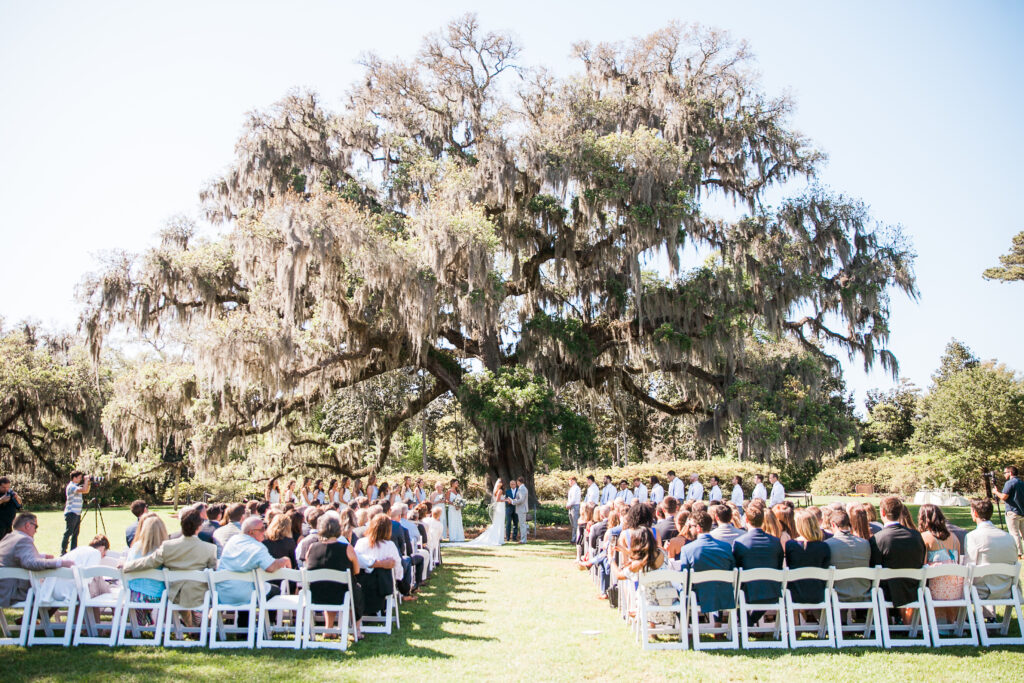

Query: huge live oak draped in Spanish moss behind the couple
left=77, top=15, right=916, bottom=497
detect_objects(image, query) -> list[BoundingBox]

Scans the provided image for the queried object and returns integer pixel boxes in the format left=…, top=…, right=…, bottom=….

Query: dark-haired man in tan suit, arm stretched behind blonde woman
left=124, top=508, right=217, bottom=607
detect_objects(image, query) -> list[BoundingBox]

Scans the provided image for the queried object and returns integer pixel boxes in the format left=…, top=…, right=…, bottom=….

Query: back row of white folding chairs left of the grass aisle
left=0, top=566, right=376, bottom=650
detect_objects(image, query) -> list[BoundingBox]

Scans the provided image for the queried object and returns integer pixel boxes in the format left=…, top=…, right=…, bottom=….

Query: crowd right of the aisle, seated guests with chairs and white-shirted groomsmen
left=566, top=470, right=1024, bottom=649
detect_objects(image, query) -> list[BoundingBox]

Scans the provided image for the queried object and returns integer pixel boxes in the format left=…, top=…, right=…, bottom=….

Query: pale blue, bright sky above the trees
left=0, top=0, right=1024, bottom=411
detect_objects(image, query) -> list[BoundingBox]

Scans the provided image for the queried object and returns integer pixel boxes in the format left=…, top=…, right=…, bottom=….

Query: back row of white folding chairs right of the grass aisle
left=620, top=563, right=1024, bottom=650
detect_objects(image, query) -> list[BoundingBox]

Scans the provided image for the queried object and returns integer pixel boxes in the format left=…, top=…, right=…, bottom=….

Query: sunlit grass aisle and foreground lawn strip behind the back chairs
left=0, top=542, right=1024, bottom=683
